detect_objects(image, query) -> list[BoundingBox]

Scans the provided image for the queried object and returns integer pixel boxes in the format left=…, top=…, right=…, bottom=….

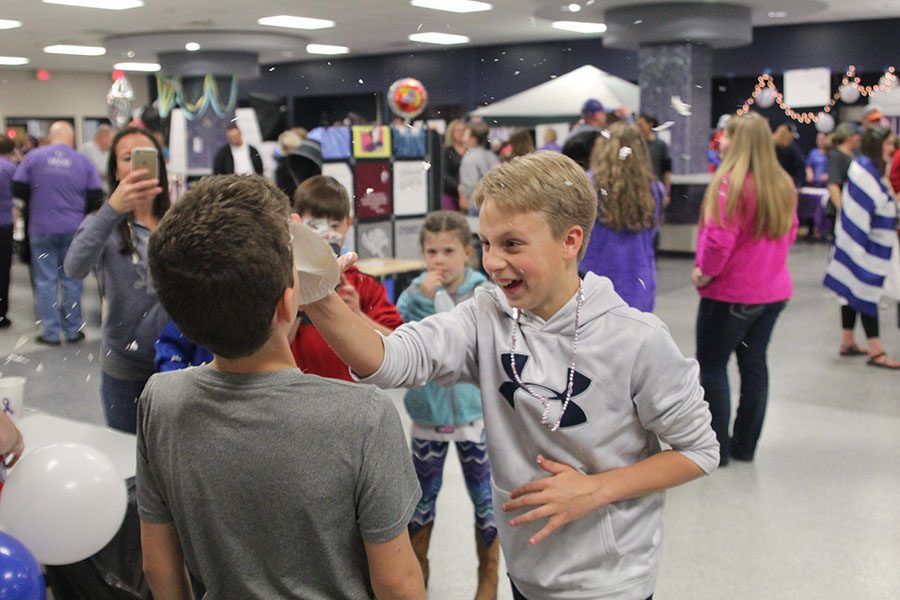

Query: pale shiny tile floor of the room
left=0, top=244, right=900, bottom=600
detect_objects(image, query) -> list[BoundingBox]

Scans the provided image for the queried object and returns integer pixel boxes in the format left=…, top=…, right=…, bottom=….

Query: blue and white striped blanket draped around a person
left=825, top=156, right=897, bottom=316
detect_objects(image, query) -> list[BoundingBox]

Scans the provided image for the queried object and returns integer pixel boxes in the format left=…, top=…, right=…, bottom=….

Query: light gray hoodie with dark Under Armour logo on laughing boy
left=363, top=273, right=719, bottom=600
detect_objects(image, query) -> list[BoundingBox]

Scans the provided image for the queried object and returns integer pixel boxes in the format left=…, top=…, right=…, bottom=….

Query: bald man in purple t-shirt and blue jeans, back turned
left=13, top=121, right=103, bottom=346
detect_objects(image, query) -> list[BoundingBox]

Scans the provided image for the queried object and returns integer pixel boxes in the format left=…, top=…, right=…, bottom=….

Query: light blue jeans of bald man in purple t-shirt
left=31, top=232, right=84, bottom=341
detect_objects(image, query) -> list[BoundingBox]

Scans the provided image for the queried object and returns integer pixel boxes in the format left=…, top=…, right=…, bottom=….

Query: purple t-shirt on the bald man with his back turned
left=13, top=144, right=100, bottom=234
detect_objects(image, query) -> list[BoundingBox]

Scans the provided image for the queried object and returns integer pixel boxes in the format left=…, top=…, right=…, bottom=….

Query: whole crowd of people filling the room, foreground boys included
left=0, top=99, right=900, bottom=600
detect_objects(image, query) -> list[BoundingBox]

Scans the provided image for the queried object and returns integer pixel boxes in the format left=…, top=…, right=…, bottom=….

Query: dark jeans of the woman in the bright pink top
left=697, top=298, right=787, bottom=464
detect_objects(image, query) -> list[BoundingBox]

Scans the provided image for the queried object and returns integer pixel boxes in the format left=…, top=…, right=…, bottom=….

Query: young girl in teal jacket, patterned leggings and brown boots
left=397, top=210, right=499, bottom=600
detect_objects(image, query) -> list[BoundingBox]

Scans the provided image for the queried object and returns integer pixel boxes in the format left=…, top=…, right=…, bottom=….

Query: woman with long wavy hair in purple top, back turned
left=579, top=123, right=665, bottom=312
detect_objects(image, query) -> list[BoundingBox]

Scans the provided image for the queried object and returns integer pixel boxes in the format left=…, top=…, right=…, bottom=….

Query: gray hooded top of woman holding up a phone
left=64, top=204, right=169, bottom=381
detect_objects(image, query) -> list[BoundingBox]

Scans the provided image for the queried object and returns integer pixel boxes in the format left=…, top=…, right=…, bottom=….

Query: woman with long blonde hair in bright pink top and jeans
left=691, top=113, right=798, bottom=465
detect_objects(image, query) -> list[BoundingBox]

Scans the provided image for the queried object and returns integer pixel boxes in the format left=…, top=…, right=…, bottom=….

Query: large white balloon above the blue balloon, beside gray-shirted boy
left=0, top=443, right=128, bottom=565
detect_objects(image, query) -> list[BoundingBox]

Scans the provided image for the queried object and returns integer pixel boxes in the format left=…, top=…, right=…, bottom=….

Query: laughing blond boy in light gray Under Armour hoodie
left=306, top=152, right=719, bottom=600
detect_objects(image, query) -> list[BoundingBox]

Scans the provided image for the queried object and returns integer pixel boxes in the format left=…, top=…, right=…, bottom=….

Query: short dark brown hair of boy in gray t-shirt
left=148, top=175, right=294, bottom=358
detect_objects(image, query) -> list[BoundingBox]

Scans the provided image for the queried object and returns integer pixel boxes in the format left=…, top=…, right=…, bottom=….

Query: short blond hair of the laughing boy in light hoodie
left=472, top=152, right=597, bottom=261
